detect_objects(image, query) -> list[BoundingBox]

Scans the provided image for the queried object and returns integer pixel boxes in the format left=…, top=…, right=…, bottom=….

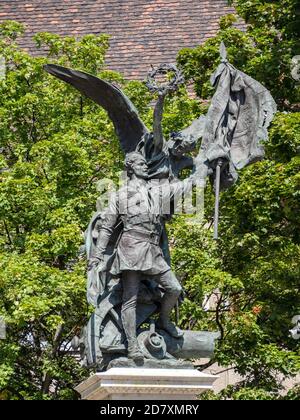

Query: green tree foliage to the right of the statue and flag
left=173, top=0, right=300, bottom=399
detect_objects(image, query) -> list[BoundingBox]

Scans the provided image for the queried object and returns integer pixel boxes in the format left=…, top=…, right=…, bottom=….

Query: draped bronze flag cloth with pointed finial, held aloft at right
left=199, top=47, right=277, bottom=189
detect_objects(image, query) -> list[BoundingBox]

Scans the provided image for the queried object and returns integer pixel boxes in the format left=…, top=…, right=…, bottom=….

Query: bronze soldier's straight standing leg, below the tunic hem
left=121, top=271, right=143, bottom=361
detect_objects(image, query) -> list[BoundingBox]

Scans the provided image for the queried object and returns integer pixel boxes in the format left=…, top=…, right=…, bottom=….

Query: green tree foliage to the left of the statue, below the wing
left=0, top=22, right=122, bottom=399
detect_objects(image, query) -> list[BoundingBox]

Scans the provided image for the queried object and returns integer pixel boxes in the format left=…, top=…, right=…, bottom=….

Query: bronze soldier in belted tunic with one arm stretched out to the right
left=89, top=152, right=200, bottom=361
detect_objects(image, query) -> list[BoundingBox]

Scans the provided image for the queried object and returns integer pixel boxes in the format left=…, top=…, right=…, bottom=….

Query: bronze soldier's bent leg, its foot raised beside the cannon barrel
left=156, top=270, right=183, bottom=337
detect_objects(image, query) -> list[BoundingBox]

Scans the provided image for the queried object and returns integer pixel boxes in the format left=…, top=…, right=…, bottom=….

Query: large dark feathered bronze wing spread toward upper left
left=44, top=64, right=148, bottom=153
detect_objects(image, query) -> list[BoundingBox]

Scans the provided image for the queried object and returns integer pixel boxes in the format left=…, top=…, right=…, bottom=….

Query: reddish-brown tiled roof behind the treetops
left=0, top=0, right=244, bottom=79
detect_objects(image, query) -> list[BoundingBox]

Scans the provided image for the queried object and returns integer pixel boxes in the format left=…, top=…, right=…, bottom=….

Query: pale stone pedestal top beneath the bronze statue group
left=76, top=368, right=218, bottom=400
